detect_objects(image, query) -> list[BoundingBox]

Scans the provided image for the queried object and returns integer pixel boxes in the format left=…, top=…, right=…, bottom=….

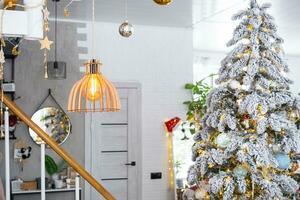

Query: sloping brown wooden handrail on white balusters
left=0, top=93, right=116, bottom=200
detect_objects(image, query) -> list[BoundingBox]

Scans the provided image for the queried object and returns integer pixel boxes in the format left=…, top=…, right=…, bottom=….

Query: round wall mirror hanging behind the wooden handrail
left=29, top=107, right=72, bottom=145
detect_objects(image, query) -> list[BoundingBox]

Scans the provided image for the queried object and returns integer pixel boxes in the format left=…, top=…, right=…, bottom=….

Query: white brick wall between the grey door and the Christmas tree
left=80, top=23, right=193, bottom=200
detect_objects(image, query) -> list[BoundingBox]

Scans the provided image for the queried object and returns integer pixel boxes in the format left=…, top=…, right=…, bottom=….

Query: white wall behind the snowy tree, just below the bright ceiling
left=194, top=50, right=300, bottom=94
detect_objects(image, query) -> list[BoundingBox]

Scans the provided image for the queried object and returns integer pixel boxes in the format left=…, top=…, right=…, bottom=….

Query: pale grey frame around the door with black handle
left=83, top=82, right=143, bottom=200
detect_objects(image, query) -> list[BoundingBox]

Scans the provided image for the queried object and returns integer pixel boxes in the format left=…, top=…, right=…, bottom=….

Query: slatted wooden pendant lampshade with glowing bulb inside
left=68, top=59, right=121, bottom=112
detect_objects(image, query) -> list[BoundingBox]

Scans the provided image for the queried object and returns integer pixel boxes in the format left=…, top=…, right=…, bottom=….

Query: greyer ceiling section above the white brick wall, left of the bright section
left=48, top=0, right=193, bottom=27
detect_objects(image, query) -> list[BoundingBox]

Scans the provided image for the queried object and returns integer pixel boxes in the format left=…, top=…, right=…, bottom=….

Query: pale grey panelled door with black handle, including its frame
left=86, top=84, right=141, bottom=200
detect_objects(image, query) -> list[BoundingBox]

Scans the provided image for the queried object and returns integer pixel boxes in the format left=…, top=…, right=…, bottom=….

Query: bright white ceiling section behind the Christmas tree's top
left=194, top=0, right=300, bottom=55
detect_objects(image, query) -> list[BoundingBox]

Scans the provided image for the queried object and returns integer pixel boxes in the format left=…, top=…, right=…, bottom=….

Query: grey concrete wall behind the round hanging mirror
left=0, top=22, right=86, bottom=200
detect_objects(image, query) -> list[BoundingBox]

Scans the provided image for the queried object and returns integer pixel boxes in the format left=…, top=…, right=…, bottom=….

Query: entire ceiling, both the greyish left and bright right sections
left=48, top=0, right=300, bottom=55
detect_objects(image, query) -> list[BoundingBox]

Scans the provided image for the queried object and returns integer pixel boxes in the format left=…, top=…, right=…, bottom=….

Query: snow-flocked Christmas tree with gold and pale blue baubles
left=188, top=0, right=300, bottom=200
